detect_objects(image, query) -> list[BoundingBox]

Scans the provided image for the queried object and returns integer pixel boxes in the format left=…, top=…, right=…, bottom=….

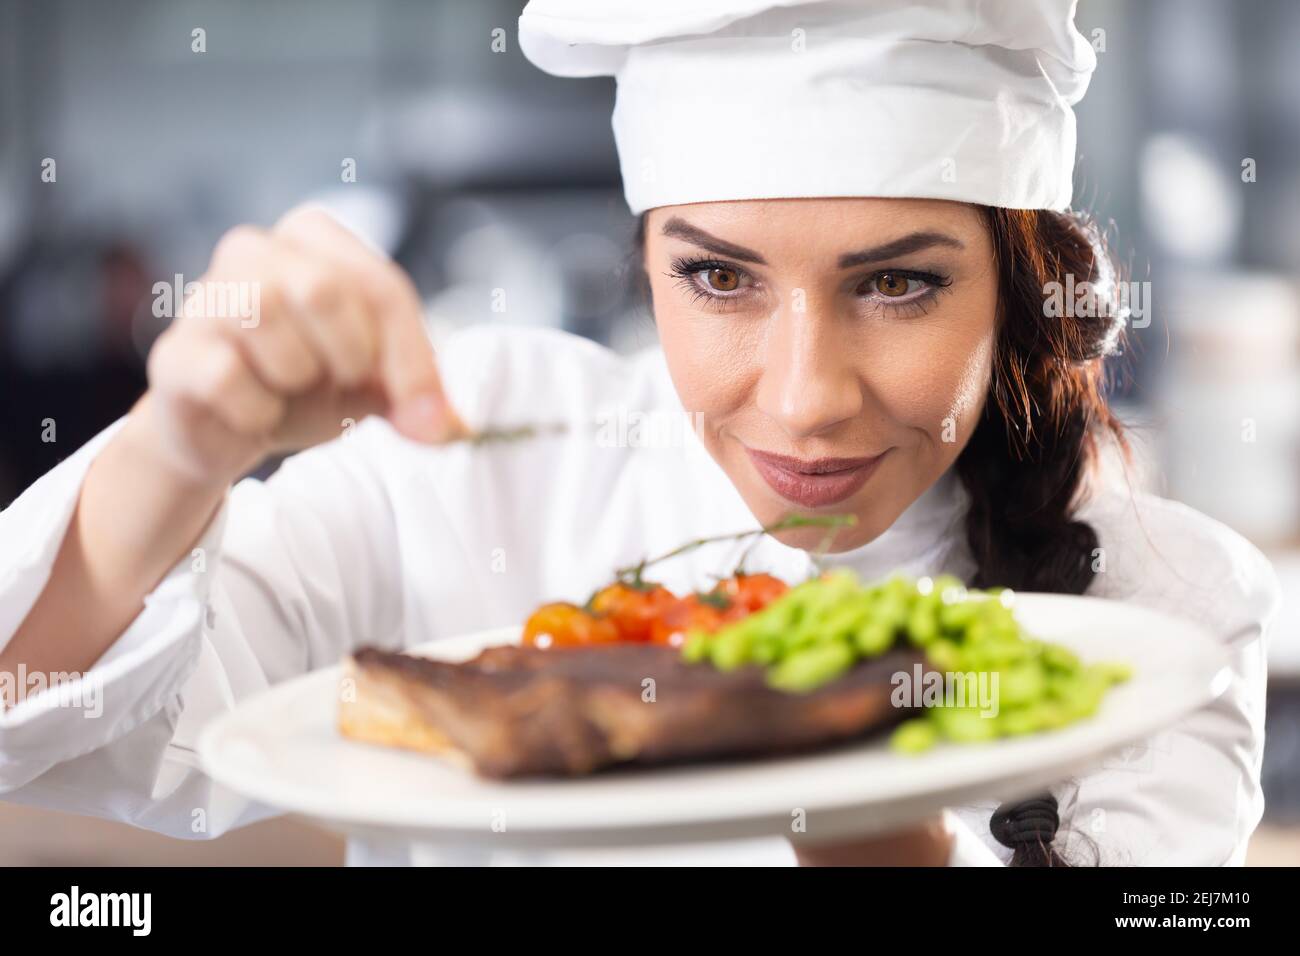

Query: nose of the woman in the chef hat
left=755, top=310, right=863, bottom=438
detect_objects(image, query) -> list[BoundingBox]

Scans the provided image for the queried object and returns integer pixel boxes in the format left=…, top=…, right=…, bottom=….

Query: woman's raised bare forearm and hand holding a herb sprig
left=0, top=209, right=464, bottom=672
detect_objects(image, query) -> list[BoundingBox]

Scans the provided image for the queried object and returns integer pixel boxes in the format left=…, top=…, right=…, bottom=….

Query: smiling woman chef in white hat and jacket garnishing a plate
left=0, top=0, right=1278, bottom=865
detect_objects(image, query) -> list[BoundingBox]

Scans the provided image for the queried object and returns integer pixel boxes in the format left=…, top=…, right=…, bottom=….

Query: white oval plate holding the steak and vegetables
left=199, top=593, right=1230, bottom=847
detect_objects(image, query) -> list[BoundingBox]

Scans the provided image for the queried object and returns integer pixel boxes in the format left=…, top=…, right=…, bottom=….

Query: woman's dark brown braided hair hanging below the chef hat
left=632, top=207, right=1127, bottom=866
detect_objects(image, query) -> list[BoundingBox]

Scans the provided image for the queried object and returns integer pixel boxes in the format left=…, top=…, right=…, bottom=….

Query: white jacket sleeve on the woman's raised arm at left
left=0, top=421, right=403, bottom=838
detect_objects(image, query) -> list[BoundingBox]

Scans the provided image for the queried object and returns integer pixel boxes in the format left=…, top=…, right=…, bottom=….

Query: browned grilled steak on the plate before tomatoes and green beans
left=339, top=644, right=922, bottom=778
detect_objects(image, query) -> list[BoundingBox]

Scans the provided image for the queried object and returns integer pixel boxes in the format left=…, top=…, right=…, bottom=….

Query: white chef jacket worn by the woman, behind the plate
left=0, top=326, right=1279, bottom=865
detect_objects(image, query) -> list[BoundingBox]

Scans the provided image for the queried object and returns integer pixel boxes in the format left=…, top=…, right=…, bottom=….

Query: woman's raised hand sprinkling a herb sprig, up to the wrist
left=131, top=201, right=463, bottom=485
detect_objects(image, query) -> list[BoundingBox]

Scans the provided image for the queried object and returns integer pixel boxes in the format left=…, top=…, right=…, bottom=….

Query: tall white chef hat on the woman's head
left=519, top=0, right=1097, bottom=213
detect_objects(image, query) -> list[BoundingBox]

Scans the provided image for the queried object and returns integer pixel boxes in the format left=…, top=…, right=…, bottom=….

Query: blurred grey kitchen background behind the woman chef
left=0, top=0, right=1300, bottom=864
